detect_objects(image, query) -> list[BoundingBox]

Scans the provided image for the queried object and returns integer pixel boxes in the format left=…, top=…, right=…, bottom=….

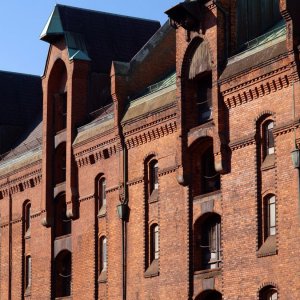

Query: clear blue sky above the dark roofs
left=0, top=0, right=180, bottom=75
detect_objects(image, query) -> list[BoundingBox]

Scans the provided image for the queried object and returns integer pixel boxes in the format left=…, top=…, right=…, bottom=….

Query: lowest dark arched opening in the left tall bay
left=55, top=250, right=72, bottom=298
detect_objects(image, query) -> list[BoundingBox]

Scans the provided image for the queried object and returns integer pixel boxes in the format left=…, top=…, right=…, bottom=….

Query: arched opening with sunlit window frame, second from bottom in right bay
left=194, top=213, right=222, bottom=271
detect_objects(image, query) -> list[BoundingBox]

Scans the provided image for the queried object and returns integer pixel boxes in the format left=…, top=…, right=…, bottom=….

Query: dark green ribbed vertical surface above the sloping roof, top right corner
left=236, top=0, right=282, bottom=47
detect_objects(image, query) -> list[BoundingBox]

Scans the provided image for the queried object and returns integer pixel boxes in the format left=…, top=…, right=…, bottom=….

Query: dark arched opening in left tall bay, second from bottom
left=54, top=193, right=71, bottom=238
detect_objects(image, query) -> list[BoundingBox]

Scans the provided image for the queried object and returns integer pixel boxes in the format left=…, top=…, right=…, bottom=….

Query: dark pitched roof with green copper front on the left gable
left=41, top=4, right=160, bottom=73
